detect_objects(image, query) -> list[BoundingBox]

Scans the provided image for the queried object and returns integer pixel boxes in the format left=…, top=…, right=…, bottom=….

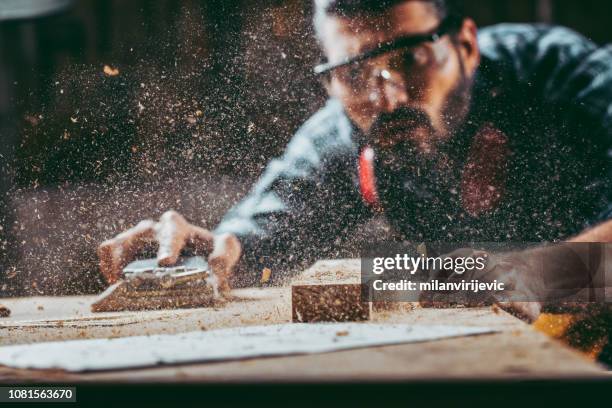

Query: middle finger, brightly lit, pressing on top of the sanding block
left=155, top=211, right=191, bottom=266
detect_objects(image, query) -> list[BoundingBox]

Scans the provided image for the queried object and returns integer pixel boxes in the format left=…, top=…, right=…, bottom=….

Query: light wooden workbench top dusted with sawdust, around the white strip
left=0, top=260, right=608, bottom=382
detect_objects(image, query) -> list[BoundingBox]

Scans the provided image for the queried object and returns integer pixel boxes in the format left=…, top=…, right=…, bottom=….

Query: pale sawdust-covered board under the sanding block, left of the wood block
left=0, top=288, right=291, bottom=345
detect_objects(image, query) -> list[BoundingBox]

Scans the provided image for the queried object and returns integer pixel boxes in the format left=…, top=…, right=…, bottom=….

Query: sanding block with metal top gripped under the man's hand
left=91, top=256, right=221, bottom=312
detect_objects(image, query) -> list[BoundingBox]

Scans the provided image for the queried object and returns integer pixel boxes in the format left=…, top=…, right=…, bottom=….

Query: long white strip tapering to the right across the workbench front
left=0, top=323, right=495, bottom=372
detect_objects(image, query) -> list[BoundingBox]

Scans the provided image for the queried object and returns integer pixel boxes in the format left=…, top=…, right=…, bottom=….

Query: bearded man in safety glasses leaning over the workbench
left=99, top=0, right=612, bottom=315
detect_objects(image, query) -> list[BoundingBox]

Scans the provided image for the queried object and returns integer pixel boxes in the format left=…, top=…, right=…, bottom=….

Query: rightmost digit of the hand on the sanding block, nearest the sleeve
left=208, top=234, right=242, bottom=293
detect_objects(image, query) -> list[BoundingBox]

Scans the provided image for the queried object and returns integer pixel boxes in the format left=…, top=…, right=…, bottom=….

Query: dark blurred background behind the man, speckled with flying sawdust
left=0, top=0, right=612, bottom=297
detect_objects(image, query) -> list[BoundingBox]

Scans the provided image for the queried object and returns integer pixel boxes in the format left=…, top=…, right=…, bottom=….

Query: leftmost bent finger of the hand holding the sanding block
left=98, top=220, right=155, bottom=283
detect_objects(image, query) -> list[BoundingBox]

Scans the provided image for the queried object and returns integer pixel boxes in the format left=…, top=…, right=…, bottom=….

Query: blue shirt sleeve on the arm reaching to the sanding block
left=215, top=100, right=367, bottom=286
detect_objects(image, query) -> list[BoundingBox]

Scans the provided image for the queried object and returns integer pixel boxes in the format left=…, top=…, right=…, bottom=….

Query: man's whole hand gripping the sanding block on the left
left=98, top=211, right=242, bottom=292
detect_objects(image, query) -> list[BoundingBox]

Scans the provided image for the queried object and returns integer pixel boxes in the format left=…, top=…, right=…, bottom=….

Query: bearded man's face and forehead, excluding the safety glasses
left=321, top=0, right=479, bottom=159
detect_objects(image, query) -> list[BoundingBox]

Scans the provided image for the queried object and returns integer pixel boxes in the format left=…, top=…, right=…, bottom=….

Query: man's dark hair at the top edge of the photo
left=314, top=0, right=465, bottom=38
